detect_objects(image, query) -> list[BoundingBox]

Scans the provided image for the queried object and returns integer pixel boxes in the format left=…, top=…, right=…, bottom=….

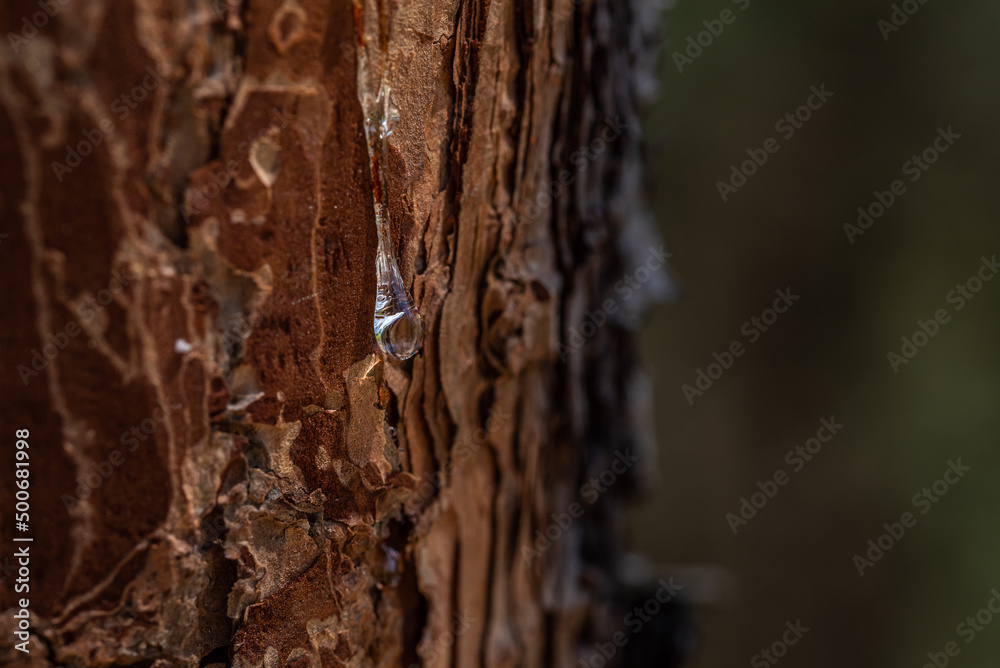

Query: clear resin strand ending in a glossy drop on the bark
left=355, top=3, right=424, bottom=361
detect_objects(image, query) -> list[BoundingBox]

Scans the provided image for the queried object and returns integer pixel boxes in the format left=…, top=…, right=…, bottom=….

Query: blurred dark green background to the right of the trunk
left=630, top=0, right=1000, bottom=668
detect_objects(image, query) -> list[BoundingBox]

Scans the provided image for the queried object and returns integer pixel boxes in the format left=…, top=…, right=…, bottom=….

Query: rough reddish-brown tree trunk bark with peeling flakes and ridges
left=0, top=0, right=672, bottom=668
